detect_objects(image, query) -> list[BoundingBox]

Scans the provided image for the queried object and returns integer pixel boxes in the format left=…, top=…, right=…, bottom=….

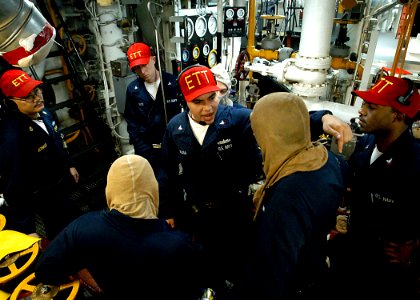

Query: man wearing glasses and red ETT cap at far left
left=0, top=69, right=80, bottom=240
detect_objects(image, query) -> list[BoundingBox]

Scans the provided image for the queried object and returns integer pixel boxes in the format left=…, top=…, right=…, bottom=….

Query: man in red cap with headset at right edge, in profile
left=331, top=76, right=420, bottom=299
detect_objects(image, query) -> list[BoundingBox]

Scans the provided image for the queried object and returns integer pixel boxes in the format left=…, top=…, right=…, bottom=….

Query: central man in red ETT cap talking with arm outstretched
left=162, top=65, right=351, bottom=298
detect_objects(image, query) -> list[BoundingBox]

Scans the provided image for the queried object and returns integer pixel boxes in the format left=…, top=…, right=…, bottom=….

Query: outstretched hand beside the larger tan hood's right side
left=322, top=115, right=353, bottom=153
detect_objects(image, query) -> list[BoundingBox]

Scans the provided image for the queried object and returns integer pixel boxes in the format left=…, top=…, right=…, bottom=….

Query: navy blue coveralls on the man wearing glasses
left=0, top=100, right=79, bottom=239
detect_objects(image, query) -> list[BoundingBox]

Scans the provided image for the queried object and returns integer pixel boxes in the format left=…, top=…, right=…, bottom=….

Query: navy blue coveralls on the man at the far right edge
left=331, top=129, right=420, bottom=299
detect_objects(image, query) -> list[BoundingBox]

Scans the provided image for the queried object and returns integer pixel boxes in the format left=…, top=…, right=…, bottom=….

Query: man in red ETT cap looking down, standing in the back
left=124, top=43, right=181, bottom=175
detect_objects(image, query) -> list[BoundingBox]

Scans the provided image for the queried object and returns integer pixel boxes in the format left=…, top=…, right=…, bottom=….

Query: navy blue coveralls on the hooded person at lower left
left=35, top=210, right=201, bottom=300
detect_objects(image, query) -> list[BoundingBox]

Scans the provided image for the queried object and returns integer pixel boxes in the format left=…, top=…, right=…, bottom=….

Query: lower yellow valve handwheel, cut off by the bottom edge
left=10, top=273, right=80, bottom=300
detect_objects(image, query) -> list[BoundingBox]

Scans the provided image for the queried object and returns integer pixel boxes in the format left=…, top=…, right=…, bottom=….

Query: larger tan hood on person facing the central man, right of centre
left=251, top=93, right=328, bottom=215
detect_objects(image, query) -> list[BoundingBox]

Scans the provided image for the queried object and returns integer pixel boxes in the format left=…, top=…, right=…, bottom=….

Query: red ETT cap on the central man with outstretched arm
left=178, top=65, right=220, bottom=102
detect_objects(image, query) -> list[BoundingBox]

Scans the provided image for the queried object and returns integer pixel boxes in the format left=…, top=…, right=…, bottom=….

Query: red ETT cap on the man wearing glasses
left=0, top=70, right=43, bottom=98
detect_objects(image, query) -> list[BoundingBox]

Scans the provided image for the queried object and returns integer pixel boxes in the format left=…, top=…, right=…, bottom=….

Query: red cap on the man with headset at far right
left=352, top=76, right=420, bottom=118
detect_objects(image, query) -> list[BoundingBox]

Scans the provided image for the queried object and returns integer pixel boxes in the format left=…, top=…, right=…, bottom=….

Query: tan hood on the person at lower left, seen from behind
left=105, top=155, right=159, bottom=219
